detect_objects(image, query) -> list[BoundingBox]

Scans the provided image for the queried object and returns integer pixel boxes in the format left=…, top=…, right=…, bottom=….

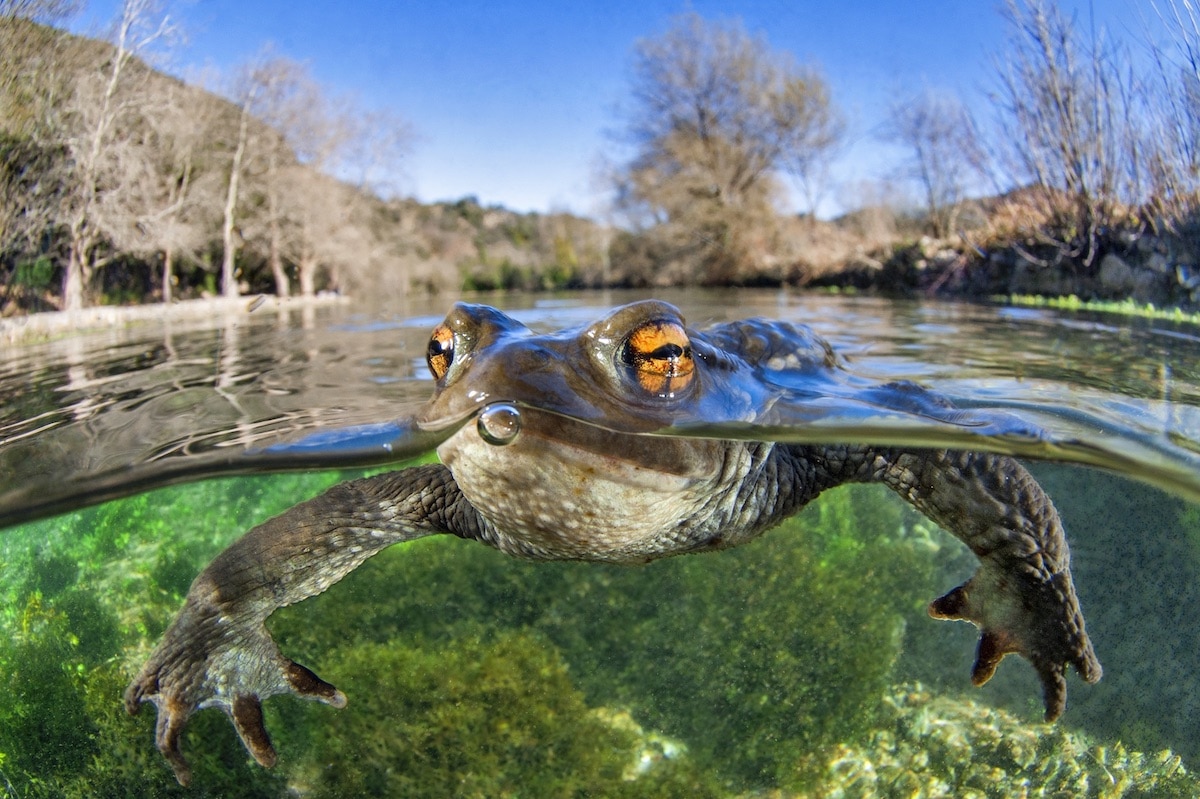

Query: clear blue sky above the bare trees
left=72, top=0, right=1152, bottom=216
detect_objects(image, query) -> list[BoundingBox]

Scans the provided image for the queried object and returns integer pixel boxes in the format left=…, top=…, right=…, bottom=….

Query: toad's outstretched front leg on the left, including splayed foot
left=125, top=465, right=482, bottom=785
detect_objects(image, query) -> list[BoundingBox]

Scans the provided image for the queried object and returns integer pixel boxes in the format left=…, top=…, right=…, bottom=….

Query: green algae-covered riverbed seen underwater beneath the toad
left=0, top=469, right=1200, bottom=798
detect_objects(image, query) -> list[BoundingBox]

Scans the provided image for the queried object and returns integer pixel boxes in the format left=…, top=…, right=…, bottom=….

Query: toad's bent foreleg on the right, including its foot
left=860, top=450, right=1102, bottom=721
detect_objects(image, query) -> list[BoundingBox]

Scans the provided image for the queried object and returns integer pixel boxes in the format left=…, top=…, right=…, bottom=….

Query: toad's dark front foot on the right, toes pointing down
left=929, top=556, right=1102, bottom=721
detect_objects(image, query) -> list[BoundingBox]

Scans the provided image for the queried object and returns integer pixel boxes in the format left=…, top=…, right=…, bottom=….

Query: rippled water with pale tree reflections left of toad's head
left=0, top=302, right=428, bottom=517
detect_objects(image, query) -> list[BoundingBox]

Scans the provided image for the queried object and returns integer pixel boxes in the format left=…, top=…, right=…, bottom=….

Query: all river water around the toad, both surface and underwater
left=0, top=292, right=1200, bottom=797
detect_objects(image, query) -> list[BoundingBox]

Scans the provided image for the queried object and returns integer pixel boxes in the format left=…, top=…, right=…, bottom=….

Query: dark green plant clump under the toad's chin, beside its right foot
left=581, top=486, right=937, bottom=787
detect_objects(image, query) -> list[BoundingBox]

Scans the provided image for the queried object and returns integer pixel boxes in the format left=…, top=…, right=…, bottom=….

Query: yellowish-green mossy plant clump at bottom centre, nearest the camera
left=276, top=632, right=719, bottom=799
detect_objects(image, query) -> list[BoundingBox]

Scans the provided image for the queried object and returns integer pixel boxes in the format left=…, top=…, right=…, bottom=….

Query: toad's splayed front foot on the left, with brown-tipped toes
left=125, top=602, right=346, bottom=785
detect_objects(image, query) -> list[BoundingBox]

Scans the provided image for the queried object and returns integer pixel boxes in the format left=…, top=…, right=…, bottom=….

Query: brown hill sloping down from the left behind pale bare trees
left=0, top=18, right=610, bottom=314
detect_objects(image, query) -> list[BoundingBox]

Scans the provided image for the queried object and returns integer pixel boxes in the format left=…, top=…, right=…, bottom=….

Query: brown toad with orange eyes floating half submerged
left=125, top=301, right=1100, bottom=785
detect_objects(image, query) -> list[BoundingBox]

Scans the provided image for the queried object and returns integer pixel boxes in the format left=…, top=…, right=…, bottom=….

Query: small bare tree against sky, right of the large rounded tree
left=886, top=90, right=988, bottom=238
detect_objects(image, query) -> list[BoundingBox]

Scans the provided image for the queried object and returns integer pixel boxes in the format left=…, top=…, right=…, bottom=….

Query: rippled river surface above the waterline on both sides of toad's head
left=0, top=290, right=1200, bottom=522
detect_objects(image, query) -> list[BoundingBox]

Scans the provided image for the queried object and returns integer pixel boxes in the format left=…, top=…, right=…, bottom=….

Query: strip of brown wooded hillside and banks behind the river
left=0, top=17, right=1200, bottom=316
